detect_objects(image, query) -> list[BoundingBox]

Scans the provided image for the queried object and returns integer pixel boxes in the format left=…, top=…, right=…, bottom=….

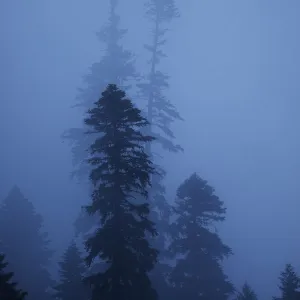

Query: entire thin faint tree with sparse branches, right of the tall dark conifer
left=137, top=0, right=183, bottom=297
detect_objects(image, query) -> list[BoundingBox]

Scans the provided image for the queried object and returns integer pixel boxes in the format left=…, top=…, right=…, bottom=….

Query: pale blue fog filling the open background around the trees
left=0, top=0, right=300, bottom=299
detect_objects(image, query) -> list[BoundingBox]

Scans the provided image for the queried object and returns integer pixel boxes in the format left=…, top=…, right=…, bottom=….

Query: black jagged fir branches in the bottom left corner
left=0, top=254, right=27, bottom=300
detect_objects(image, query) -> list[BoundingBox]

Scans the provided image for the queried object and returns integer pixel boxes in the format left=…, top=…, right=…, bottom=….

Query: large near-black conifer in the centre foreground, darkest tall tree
left=85, top=84, right=157, bottom=300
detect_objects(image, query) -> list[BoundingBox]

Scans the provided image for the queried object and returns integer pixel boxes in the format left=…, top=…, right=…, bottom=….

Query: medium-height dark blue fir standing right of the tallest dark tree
left=169, top=174, right=234, bottom=300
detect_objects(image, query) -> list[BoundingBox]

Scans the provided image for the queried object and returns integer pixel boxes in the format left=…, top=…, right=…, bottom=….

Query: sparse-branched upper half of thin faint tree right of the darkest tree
left=138, top=0, right=182, bottom=152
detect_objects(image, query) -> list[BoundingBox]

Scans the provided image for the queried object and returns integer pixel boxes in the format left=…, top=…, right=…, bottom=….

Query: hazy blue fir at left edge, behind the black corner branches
left=0, top=186, right=53, bottom=300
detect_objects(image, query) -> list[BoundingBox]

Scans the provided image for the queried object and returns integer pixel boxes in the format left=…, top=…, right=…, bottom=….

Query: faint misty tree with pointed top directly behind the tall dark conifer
left=63, top=0, right=138, bottom=240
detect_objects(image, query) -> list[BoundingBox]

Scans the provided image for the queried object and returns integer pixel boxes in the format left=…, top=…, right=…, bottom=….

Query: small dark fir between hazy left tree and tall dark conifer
left=54, top=242, right=89, bottom=300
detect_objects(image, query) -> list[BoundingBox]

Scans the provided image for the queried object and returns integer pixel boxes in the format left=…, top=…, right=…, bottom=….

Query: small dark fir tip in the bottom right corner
left=273, top=264, right=300, bottom=300
